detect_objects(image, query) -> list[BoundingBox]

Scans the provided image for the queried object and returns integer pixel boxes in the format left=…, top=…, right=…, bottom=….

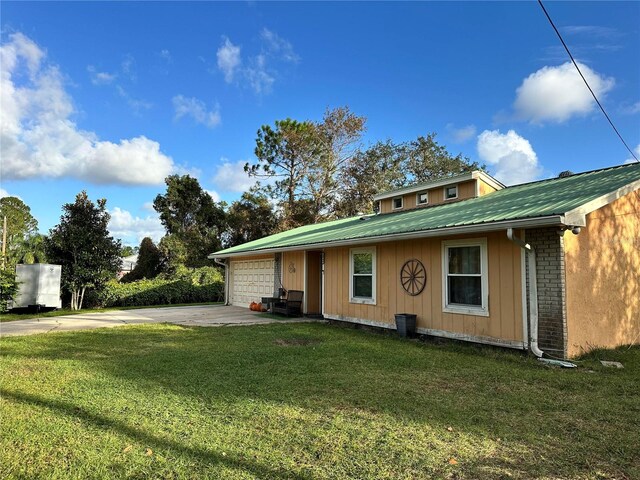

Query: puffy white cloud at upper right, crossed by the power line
left=513, top=62, right=615, bottom=123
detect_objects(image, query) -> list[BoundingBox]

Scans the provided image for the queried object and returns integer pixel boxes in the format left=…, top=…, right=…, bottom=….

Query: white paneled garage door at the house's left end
left=229, top=260, right=274, bottom=308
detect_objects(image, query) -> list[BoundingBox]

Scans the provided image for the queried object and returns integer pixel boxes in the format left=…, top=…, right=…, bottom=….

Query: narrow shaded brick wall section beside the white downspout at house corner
left=525, top=227, right=567, bottom=358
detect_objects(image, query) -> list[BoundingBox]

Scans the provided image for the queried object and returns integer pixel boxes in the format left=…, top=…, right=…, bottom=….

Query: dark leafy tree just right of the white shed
left=45, top=191, right=121, bottom=310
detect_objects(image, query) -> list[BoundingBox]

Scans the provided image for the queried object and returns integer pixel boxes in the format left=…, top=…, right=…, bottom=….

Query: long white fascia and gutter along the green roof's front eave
left=207, top=215, right=566, bottom=259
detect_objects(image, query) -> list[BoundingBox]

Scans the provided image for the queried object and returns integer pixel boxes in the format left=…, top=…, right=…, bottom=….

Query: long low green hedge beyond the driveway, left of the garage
left=94, top=278, right=224, bottom=307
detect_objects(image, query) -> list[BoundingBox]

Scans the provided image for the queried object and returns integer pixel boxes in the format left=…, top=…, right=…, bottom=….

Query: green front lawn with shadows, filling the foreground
left=0, top=324, right=640, bottom=479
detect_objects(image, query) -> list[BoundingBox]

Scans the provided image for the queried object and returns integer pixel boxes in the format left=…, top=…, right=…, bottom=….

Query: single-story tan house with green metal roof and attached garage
left=210, top=164, right=640, bottom=358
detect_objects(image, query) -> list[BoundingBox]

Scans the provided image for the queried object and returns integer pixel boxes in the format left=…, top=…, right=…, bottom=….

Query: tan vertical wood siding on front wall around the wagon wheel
left=324, top=232, right=523, bottom=342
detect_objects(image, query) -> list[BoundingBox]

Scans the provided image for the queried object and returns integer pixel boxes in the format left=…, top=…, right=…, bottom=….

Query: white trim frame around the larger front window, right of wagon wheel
left=442, top=238, right=489, bottom=317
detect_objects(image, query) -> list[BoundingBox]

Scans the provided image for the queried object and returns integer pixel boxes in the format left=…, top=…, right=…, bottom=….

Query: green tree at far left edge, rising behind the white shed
left=0, top=197, right=44, bottom=270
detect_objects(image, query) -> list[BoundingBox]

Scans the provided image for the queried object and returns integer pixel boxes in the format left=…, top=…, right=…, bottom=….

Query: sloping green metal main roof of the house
left=210, top=163, right=640, bottom=257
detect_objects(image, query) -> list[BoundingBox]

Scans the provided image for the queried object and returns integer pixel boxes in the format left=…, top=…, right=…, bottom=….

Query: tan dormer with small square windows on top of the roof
left=373, top=170, right=504, bottom=213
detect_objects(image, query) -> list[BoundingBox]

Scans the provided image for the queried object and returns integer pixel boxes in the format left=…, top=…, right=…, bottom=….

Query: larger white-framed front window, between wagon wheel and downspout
left=442, top=238, right=489, bottom=316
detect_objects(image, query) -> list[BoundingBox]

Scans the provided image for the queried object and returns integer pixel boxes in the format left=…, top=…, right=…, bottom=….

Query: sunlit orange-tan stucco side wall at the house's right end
left=564, top=191, right=640, bottom=356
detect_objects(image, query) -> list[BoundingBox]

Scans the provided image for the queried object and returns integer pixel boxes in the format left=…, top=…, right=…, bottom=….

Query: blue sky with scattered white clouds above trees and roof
left=0, top=2, right=640, bottom=245
